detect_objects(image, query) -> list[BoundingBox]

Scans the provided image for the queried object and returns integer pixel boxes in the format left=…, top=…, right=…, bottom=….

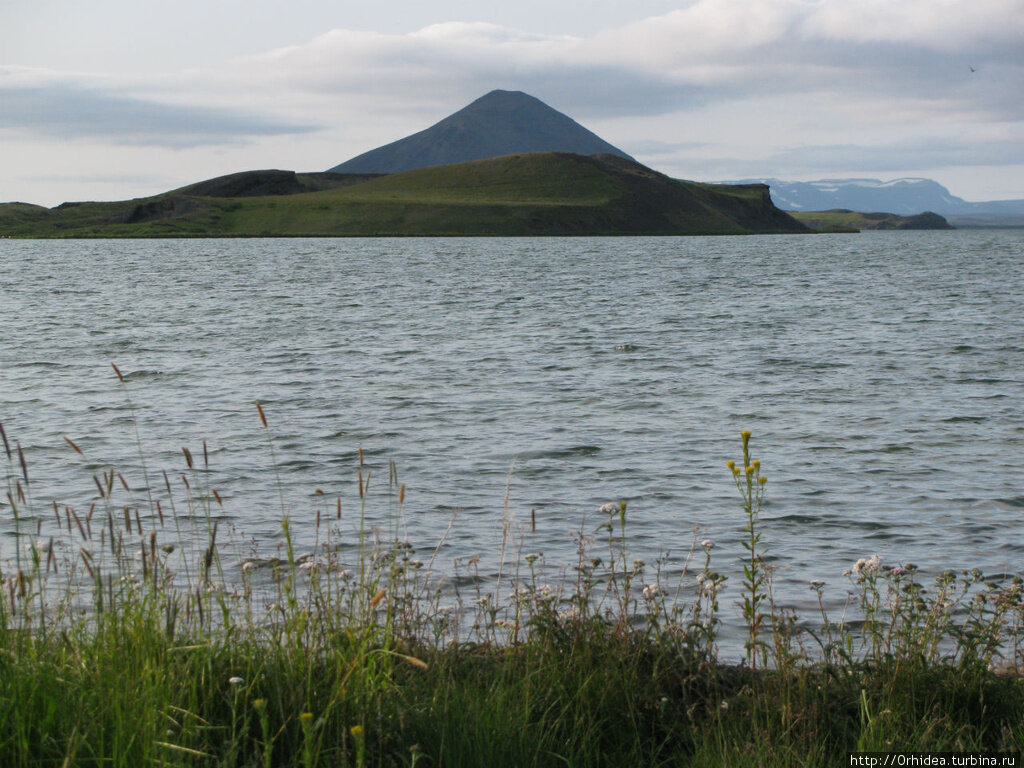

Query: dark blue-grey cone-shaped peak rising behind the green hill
left=330, top=90, right=632, bottom=173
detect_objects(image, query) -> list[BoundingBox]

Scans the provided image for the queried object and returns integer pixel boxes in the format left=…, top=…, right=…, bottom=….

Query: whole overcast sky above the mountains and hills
left=0, top=0, right=1024, bottom=206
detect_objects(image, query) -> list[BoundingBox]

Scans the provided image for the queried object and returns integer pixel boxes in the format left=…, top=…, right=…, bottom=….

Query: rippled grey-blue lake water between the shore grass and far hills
left=0, top=230, right=1024, bottom=643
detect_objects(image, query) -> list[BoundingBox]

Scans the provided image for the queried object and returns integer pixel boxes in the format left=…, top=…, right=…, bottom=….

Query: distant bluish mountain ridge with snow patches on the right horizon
left=735, top=178, right=1024, bottom=216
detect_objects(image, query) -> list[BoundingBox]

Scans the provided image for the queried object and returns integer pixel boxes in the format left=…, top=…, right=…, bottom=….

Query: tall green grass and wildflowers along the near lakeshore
left=0, top=380, right=1024, bottom=768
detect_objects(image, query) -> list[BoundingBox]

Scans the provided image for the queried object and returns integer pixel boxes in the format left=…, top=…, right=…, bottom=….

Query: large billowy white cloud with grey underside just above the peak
left=207, top=0, right=1024, bottom=124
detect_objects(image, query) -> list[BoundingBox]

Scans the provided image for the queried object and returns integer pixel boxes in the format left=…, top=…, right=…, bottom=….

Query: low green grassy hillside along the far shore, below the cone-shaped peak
left=0, top=153, right=807, bottom=238
